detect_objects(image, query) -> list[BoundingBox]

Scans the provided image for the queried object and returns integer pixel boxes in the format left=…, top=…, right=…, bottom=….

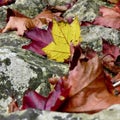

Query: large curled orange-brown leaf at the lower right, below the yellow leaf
left=60, top=44, right=120, bottom=113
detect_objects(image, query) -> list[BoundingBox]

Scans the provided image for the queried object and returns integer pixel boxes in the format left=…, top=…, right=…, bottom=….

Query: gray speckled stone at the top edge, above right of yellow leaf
left=64, top=0, right=106, bottom=21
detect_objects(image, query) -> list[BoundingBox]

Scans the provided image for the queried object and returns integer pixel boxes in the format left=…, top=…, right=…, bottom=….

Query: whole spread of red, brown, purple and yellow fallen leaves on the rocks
left=1, top=0, right=120, bottom=113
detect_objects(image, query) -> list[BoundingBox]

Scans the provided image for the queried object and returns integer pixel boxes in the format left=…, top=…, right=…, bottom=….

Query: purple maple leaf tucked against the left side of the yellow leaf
left=22, top=23, right=53, bottom=55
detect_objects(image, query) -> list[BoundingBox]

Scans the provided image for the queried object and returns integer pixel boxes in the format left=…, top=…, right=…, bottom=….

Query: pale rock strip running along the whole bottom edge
left=0, top=105, right=120, bottom=120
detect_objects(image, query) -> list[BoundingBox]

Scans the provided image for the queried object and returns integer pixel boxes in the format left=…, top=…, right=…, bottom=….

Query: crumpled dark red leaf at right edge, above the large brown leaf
left=102, top=40, right=120, bottom=73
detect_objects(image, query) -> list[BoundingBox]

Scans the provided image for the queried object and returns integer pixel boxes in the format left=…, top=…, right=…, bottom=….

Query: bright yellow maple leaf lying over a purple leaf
left=42, top=18, right=81, bottom=62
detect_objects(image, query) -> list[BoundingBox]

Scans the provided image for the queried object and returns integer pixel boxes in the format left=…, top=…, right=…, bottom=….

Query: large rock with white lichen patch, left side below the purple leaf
left=0, top=46, right=68, bottom=113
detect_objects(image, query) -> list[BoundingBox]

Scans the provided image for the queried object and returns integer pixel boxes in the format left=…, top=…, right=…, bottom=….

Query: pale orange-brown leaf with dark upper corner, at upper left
left=2, top=8, right=35, bottom=36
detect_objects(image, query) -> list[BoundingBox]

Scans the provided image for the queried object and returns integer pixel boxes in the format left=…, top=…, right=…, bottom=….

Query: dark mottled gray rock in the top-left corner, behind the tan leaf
left=0, top=0, right=46, bottom=28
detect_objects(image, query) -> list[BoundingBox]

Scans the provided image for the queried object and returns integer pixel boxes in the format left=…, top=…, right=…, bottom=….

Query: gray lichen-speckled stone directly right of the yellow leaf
left=81, top=25, right=120, bottom=51
